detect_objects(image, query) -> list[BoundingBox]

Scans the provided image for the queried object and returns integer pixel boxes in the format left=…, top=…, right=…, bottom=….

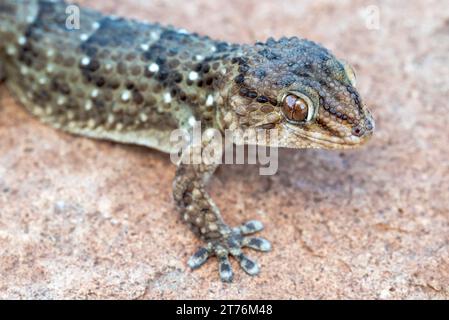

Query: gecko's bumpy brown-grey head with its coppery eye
left=225, top=37, right=374, bottom=149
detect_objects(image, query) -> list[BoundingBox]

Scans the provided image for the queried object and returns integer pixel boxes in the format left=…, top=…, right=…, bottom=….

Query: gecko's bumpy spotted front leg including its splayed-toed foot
left=173, top=141, right=271, bottom=282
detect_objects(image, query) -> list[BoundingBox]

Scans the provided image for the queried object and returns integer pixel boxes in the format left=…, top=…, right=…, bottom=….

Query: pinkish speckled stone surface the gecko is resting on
left=0, top=0, right=449, bottom=299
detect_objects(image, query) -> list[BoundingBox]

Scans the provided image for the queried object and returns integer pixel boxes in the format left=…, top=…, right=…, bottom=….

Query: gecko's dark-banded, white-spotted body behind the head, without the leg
left=0, top=0, right=229, bottom=152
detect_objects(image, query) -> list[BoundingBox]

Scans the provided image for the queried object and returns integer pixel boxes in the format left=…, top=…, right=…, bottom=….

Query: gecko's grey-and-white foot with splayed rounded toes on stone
left=188, top=220, right=271, bottom=282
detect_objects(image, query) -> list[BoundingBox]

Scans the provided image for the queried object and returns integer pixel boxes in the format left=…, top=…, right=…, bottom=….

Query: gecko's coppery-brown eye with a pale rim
left=282, top=93, right=314, bottom=123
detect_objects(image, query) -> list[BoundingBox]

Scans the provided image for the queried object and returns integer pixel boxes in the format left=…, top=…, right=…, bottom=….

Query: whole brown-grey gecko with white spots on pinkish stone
left=0, top=0, right=374, bottom=281
